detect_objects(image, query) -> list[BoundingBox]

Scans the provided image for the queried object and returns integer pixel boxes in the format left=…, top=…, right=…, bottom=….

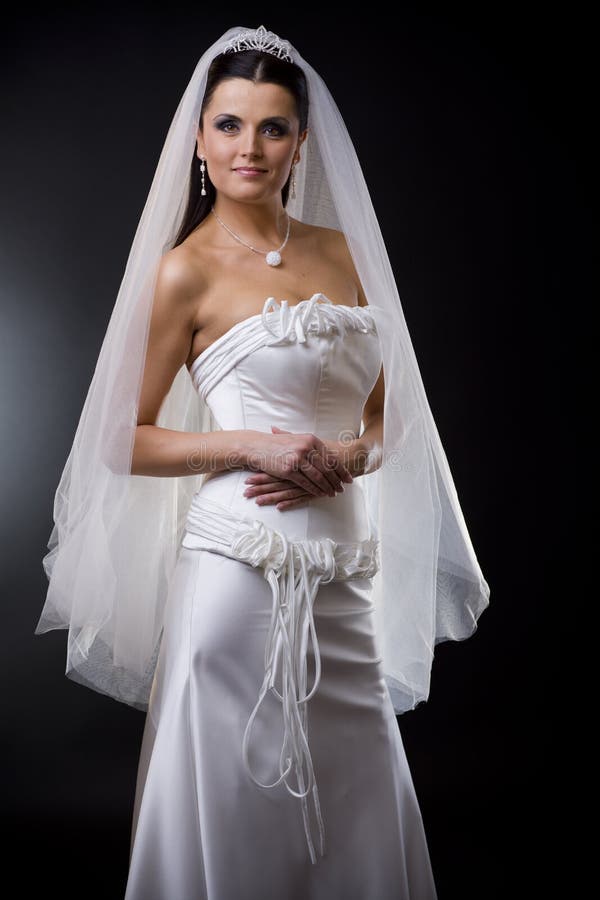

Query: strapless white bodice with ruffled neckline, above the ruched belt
left=190, top=293, right=382, bottom=541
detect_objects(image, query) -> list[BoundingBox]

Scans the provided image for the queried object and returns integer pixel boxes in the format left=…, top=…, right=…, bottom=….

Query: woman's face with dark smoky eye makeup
left=196, top=78, right=306, bottom=201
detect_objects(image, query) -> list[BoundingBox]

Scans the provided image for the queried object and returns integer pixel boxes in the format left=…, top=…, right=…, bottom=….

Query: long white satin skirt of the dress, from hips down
left=125, top=496, right=437, bottom=900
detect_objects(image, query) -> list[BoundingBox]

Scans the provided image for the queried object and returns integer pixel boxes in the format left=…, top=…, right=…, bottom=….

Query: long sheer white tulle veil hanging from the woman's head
left=35, top=26, right=489, bottom=713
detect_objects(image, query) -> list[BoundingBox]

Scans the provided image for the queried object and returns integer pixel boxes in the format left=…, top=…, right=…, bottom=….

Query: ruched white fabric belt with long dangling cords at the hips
left=181, top=492, right=379, bottom=863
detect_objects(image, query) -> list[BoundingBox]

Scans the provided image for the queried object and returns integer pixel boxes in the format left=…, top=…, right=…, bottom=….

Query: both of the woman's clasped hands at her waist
left=244, top=425, right=354, bottom=510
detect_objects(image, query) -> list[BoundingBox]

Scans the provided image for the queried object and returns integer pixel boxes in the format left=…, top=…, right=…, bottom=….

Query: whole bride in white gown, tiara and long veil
left=37, top=26, right=489, bottom=900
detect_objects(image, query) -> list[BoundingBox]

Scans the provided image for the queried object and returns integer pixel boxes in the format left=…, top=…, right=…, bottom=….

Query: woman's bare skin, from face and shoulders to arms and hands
left=132, top=74, right=383, bottom=509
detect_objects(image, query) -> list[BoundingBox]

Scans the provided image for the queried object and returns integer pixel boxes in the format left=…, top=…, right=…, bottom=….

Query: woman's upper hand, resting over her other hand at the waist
left=246, top=425, right=354, bottom=497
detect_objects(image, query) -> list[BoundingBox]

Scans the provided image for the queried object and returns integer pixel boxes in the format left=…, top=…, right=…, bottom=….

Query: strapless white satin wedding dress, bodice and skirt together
left=125, top=293, right=436, bottom=900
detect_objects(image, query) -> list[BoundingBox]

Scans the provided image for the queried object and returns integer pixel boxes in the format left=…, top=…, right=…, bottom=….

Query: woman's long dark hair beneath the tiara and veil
left=173, top=50, right=308, bottom=247
